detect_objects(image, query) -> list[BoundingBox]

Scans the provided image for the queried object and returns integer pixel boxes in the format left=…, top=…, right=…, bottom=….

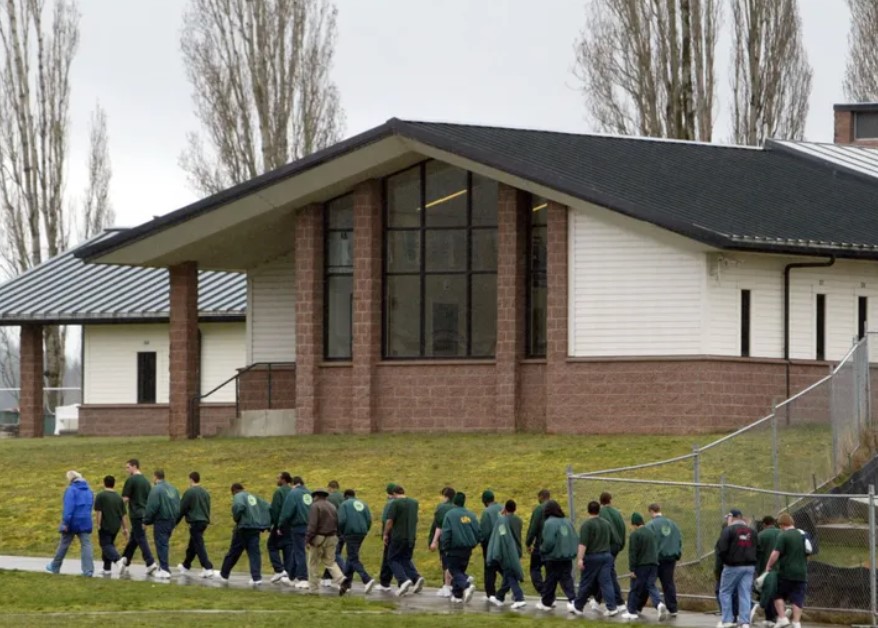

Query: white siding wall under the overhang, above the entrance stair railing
left=247, top=255, right=296, bottom=364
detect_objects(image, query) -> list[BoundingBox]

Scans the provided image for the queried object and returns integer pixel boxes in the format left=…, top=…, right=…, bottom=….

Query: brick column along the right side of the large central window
left=496, top=184, right=527, bottom=429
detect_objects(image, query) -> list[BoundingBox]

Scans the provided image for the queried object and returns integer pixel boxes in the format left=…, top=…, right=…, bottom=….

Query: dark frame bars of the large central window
left=381, top=159, right=499, bottom=362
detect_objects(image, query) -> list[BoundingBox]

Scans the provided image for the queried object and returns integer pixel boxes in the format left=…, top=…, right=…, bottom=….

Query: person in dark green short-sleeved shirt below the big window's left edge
left=384, top=484, right=424, bottom=596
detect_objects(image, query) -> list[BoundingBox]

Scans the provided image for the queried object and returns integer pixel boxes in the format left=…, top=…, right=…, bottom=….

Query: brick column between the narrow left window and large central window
left=351, top=179, right=381, bottom=434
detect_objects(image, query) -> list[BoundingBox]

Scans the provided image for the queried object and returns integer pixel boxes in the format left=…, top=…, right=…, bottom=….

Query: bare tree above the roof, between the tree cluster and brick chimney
left=731, top=0, right=812, bottom=146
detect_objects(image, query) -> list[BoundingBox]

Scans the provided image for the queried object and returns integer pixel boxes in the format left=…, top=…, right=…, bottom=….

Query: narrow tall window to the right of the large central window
left=526, top=196, right=548, bottom=358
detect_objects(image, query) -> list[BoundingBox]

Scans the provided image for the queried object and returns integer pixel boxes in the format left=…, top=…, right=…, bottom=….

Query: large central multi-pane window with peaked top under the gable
left=384, top=161, right=497, bottom=358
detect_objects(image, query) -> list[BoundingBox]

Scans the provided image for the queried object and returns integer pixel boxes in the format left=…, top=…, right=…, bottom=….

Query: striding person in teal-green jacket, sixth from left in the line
left=220, top=482, right=271, bottom=587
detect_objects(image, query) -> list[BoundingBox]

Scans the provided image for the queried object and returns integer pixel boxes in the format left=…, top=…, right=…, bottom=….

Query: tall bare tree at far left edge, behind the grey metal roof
left=0, top=0, right=79, bottom=412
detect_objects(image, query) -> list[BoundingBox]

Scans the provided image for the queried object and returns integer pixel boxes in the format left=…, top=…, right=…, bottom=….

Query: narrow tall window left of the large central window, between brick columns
left=323, top=194, right=354, bottom=360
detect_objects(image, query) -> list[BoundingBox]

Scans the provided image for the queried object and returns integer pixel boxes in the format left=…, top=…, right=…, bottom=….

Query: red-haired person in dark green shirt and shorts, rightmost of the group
left=765, top=513, right=810, bottom=628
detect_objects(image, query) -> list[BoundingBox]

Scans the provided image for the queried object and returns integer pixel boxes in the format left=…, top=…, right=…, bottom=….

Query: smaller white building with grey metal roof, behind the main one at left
left=0, top=229, right=247, bottom=435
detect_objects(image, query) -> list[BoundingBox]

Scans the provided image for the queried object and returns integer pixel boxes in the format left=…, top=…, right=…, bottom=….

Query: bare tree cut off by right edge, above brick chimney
left=844, top=0, right=878, bottom=102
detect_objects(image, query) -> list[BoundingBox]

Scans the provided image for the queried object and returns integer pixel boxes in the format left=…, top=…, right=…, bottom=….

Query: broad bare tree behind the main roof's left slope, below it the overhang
left=180, top=0, right=343, bottom=193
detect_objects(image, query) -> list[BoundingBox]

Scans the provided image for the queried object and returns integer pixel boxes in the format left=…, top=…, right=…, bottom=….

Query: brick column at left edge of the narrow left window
left=295, top=205, right=323, bottom=434
